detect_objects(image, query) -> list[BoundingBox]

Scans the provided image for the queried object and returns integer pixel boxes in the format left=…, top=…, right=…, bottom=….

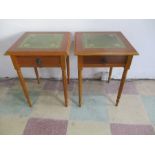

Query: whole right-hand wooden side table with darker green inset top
left=74, top=32, right=138, bottom=106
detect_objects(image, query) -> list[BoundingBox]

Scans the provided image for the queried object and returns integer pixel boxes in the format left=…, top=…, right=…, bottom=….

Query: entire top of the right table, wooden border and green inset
left=75, top=32, right=138, bottom=55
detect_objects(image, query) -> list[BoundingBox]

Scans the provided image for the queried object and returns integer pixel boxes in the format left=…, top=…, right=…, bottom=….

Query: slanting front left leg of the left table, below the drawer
left=17, top=69, right=32, bottom=107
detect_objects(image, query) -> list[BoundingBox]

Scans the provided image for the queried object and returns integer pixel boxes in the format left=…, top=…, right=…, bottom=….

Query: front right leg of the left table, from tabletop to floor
left=61, top=56, right=68, bottom=107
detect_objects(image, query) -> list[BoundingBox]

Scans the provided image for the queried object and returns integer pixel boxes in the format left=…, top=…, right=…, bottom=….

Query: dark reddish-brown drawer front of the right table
left=83, top=56, right=127, bottom=66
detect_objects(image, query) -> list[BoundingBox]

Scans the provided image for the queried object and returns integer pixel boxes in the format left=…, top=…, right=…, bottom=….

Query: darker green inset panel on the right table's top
left=82, top=33, right=126, bottom=48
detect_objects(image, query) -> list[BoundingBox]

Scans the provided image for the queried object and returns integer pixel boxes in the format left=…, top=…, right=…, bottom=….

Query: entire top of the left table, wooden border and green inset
left=6, top=32, right=70, bottom=55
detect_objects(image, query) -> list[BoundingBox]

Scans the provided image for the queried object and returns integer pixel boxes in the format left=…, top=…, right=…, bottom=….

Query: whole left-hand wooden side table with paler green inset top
left=6, top=32, right=70, bottom=107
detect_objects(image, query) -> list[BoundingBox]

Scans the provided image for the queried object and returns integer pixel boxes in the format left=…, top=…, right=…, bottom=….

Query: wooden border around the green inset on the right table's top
left=74, top=32, right=138, bottom=56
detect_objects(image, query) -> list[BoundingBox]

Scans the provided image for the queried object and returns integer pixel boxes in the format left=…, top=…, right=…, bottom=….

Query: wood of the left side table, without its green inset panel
left=5, top=32, right=70, bottom=107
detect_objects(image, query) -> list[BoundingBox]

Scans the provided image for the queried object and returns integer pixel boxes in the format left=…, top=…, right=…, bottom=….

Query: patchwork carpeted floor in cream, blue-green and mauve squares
left=0, top=79, right=155, bottom=135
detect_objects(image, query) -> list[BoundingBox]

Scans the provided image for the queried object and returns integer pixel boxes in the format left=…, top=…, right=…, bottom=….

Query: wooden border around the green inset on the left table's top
left=5, top=32, right=70, bottom=56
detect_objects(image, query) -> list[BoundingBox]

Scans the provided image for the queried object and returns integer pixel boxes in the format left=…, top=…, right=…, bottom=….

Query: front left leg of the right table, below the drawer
left=78, top=69, right=82, bottom=107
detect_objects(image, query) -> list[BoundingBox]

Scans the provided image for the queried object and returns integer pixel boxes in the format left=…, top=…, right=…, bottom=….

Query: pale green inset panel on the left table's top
left=18, top=34, right=64, bottom=49
